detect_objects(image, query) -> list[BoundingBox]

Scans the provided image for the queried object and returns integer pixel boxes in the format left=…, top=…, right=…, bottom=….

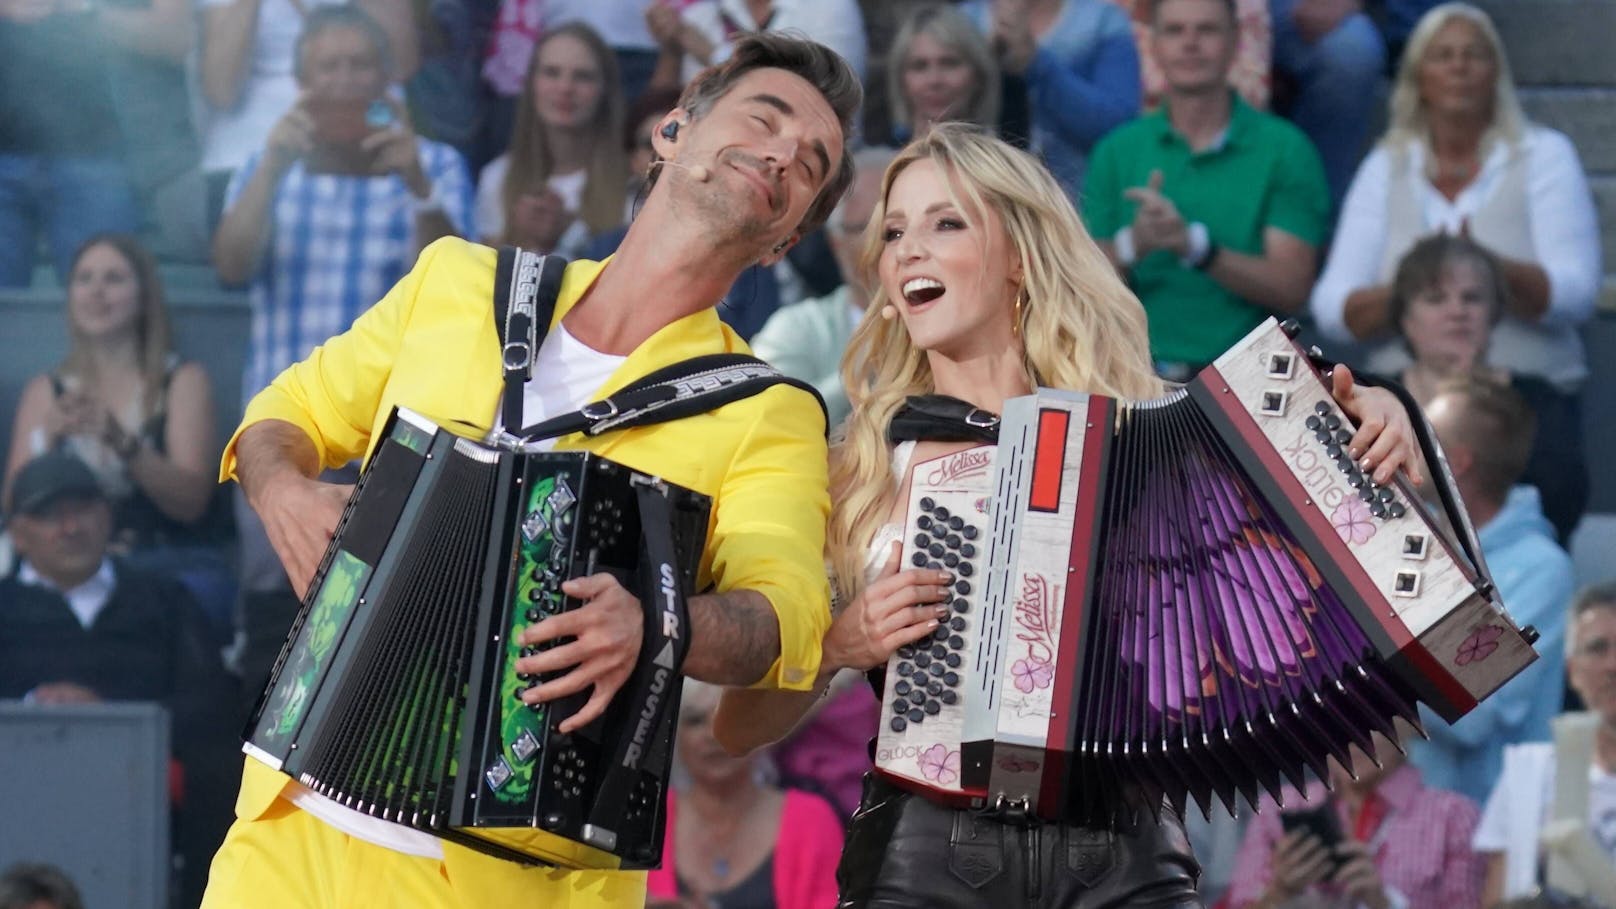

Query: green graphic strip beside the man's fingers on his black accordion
left=483, top=474, right=579, bottom=804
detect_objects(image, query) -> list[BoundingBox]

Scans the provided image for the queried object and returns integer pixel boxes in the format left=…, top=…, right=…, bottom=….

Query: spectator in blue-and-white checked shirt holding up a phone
left=213, top=0, right=472, bottom=701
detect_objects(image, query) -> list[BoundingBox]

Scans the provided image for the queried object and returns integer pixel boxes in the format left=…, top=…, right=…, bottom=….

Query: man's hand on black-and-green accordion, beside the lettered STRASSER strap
left=516, top=573, right=645, bottom=733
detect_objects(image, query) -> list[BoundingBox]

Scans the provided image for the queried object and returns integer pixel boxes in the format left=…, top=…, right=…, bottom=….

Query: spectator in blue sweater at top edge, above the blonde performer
left=962, top=0, right=1139, bottom=199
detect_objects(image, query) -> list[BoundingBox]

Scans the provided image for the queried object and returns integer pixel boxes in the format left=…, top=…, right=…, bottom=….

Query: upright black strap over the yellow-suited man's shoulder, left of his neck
left=494, top=246, right=567, bottom=432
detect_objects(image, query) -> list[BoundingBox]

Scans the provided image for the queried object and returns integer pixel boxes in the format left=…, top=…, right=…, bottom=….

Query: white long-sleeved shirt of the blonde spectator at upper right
left=1311, top=126, right=1603, bottom=387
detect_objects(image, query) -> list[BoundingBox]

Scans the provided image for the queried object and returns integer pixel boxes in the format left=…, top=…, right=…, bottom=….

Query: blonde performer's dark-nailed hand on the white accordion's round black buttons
left=824, top=543, right=953, bottom=671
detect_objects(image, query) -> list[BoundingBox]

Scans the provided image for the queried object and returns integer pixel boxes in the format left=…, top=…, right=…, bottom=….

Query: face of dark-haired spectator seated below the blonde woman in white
left=1403, top=259, right=1498, bottom=369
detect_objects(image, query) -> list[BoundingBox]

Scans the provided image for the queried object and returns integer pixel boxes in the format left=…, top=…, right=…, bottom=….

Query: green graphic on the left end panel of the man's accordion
left=259, top=550, right=370, bottom=752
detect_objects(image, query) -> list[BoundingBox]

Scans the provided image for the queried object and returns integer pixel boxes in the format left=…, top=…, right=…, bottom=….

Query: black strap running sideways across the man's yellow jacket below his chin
left=516, top=354, right=829, bottom=442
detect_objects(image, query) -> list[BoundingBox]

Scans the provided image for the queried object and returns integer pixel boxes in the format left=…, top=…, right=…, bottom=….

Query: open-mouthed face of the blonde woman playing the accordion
left=877, top=159, right=1021, bottom=361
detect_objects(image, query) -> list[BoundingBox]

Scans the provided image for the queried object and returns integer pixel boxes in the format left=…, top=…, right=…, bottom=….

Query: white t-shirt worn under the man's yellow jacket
left=286, top=325, right=627, bottom=859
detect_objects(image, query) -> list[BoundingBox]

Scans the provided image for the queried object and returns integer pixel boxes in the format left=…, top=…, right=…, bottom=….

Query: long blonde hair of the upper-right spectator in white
left=1382, top=3, right=1527, bottom=160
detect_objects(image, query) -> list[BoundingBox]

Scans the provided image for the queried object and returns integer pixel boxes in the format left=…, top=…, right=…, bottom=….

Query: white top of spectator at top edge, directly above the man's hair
left=680, top=0, right=869, bottom=82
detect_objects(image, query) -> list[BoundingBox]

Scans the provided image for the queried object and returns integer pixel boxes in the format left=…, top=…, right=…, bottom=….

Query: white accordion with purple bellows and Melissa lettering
left=876, top=320, right=1535, bottom=823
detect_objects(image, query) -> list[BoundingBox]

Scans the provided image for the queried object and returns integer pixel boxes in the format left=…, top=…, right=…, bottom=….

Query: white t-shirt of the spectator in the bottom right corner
left=1471, top=742, right=1616, bottom=899
